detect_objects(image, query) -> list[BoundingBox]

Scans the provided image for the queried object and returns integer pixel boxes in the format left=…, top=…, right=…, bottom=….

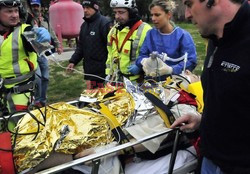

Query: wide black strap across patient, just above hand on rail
left=144, top=92, right=175, bottom=124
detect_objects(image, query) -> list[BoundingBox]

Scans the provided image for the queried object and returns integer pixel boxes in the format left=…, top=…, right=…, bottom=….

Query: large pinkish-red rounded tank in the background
left=49, top=0, right=84, bottom=39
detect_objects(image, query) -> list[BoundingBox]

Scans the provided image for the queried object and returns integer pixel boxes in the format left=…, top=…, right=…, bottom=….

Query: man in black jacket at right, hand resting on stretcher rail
left=172, top=0, right=250, bottom=174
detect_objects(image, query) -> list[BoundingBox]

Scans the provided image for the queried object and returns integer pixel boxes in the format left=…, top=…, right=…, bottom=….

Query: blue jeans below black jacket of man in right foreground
left=201, top=157, right=224, bottom=174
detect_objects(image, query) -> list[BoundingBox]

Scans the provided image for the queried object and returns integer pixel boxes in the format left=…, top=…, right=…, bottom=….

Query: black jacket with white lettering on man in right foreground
left=201, top=1, right=250, bottom=174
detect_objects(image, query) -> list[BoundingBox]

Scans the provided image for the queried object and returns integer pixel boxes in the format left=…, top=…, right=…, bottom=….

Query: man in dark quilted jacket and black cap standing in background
left=67, top=0, right=111, bottom=89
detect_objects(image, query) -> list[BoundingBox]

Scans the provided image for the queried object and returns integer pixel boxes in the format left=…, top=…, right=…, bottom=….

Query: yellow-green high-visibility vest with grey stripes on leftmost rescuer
left=0, top=24, right=37, bottom=88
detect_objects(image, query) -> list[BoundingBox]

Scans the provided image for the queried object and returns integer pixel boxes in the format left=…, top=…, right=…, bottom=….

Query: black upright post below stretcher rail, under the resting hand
left=168, top=128, right=181, bottom=174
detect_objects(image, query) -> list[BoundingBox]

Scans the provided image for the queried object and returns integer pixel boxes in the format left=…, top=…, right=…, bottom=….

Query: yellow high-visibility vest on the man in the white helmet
left=105, top=23, right=151, bottom=80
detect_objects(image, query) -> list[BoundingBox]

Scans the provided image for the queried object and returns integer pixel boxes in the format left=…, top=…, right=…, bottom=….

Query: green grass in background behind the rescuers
left=47, top=23, right=205, bottom=103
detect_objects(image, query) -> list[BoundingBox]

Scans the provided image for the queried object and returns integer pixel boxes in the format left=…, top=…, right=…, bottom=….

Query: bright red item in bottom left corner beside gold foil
left=0, top=132, right=15, bottom=174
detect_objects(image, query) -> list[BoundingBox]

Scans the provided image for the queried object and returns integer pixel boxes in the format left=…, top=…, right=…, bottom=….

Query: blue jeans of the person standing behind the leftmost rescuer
left=35, top=56, right=49, bottom=103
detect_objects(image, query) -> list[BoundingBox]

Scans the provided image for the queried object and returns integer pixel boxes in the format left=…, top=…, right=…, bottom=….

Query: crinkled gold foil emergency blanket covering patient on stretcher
left=14, top=90, right=134, bottom=172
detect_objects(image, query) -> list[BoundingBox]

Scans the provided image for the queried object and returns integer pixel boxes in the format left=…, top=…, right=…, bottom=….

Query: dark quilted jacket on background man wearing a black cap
left=69, top=12, right=111, bottom=81
